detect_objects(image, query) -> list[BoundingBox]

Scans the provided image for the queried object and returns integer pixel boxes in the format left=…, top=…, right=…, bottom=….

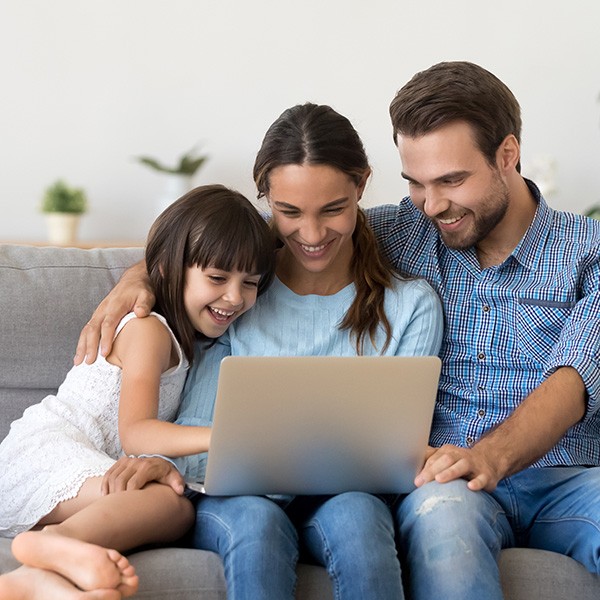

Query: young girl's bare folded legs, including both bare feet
left=5, top=478, right=195, bottom=600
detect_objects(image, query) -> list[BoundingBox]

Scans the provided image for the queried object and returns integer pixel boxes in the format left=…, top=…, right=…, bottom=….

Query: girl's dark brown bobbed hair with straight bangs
left=146, top=185, right=275, bottom=364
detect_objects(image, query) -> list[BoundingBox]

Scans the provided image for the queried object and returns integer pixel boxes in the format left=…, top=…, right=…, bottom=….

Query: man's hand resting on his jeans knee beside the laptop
left=415, top=444, right=502, bottom=492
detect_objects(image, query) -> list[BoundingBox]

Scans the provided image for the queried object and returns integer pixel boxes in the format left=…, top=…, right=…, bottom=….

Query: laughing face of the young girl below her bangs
left=183, top=266, right=260, bottom=338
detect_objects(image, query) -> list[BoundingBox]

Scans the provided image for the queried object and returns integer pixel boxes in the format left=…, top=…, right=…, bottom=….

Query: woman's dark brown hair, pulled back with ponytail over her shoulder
left=254, top=103, right=396, bottom=354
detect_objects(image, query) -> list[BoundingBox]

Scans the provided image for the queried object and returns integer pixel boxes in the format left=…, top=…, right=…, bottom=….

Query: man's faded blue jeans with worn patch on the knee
left=397, top=467, right=600, bottom=600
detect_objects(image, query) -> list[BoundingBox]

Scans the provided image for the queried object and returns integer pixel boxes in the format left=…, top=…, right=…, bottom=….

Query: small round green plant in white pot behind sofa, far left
left=41, top=179, right=88, bottom=246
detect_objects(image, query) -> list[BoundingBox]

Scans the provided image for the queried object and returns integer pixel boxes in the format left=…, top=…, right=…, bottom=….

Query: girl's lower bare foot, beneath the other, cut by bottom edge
left=0, top=567, right=122, bottom=600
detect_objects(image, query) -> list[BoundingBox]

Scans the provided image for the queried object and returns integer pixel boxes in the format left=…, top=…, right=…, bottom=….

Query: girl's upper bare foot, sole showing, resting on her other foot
left=12, top=528, right=139, bottom=598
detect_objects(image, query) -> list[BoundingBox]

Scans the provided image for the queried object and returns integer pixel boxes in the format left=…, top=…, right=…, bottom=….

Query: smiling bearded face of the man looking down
left=397, top=122, right=509, bottom=249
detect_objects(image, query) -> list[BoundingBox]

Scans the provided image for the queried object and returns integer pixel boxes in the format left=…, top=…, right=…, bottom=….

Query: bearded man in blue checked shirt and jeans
left=370, top=62, right=600, bottom=600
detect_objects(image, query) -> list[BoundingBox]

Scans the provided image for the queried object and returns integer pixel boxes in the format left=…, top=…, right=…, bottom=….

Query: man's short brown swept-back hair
left=390, top=61, right=521, bottom=170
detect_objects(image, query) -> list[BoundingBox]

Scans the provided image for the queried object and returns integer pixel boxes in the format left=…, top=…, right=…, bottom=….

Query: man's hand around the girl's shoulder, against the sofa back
left=73, top=261, right=155, bottom=365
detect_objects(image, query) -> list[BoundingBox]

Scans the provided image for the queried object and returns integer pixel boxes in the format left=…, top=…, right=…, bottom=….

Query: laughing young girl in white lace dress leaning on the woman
left=0, top=185, right=274, bottom=600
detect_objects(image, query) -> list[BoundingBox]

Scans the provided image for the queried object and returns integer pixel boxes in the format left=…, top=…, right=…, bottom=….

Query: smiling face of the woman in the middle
left=267, top=164, right=368, bottom=276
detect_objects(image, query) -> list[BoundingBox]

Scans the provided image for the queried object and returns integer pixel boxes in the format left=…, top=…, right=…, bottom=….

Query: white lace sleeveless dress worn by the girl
left=0, top=313, right=188, bottom=537
